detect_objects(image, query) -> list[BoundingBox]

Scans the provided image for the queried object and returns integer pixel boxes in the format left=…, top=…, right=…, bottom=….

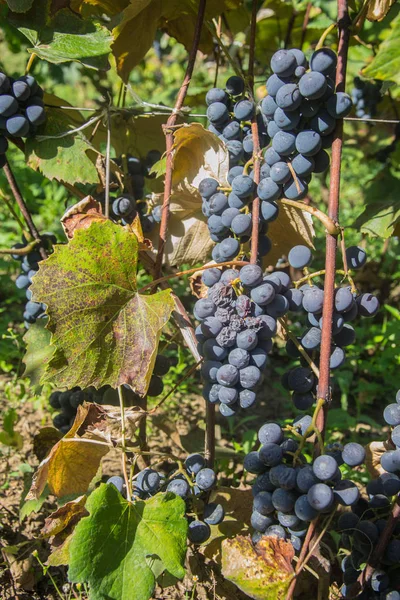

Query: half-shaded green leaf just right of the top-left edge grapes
left=25, top=94, right=99, bottom=185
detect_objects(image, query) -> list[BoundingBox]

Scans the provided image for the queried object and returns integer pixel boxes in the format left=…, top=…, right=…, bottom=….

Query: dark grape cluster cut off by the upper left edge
left=0, top=72, right=46, bottom=157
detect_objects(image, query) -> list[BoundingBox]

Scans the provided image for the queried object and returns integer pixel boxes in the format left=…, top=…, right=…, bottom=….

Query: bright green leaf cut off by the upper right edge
left=362, top=15, right=400, bottom=84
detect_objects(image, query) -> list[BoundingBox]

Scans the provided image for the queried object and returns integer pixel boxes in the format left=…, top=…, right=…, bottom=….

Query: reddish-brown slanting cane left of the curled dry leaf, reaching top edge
left=154, top=0, right=206, bottom=278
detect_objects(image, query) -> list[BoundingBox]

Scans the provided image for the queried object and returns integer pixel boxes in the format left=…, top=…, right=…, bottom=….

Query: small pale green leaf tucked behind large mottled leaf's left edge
left=23, top=319, right=54, bottom=386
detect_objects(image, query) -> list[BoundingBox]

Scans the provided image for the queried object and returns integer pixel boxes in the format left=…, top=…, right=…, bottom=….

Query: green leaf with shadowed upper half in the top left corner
left=9, top=0, right=113, bottom=69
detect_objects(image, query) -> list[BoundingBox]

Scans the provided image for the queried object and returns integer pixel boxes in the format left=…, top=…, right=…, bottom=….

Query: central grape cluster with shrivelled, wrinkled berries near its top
left=194, top=264, right=291, bottom=417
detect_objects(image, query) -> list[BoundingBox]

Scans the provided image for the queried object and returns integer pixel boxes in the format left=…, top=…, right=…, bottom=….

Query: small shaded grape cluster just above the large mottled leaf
left=111, top=150, right=161, bottom=233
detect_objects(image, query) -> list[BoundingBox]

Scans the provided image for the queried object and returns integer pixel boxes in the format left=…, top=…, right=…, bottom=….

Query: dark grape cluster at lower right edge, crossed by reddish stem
left=337, top=390, right=400, bottom=600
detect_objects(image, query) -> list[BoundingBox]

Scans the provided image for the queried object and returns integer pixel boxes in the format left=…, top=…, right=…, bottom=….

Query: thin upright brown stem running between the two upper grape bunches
left=250, top=0, right=261, bottom=265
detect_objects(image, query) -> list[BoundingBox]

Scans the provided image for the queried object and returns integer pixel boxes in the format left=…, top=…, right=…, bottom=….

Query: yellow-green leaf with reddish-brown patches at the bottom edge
left=222, top=536, right=294, bottom=600
